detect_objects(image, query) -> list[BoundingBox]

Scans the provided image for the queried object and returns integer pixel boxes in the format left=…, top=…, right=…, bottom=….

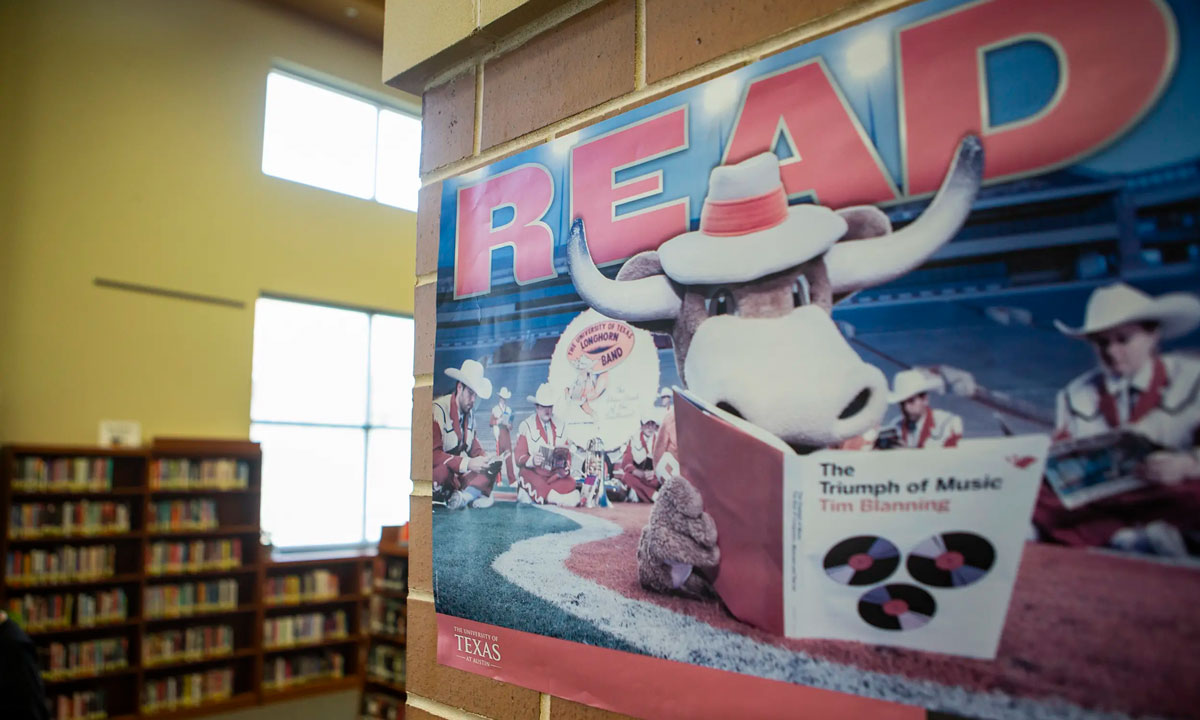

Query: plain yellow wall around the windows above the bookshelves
left=0, top=0, right=416, bottom=443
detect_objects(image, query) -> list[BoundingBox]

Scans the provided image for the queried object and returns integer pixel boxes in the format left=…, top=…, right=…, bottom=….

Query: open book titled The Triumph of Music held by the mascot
left=674, top=389, right=1050, bottom=658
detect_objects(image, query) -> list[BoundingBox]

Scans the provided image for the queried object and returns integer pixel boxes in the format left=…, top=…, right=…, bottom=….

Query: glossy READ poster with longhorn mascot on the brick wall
left=432, top=0, right=1200, bottom=718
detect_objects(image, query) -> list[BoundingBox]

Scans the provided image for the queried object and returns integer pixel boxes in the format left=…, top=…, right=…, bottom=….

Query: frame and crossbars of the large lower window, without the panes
left=250, top=292, right=416, bottom=556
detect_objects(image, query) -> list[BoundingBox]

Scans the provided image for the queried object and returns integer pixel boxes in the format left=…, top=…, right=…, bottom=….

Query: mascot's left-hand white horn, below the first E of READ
left=566, top=218, right=683, bottom=323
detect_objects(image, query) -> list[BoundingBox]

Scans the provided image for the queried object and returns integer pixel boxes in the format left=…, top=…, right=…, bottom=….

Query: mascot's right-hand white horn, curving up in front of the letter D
left=824, top=136, right=983, bottom=294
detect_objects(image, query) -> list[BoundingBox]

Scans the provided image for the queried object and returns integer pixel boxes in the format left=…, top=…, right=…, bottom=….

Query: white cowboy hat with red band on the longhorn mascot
left=659, top=152, right=848, bottom=284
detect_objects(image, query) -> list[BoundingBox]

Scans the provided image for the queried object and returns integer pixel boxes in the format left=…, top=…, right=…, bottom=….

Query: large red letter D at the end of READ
left=899, top=0, right=1176, bottom=194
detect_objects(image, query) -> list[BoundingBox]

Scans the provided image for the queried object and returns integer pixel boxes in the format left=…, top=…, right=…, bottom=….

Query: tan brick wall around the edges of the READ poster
left=408, top=0, right=911, bottom=720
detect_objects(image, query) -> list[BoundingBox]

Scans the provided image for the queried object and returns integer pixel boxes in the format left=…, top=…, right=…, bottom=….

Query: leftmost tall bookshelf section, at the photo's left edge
left=0, top=445, right=149, bottom=718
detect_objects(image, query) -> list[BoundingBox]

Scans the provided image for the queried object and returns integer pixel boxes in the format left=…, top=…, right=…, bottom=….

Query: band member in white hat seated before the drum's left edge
left=515, top=383, right=580, bottom=508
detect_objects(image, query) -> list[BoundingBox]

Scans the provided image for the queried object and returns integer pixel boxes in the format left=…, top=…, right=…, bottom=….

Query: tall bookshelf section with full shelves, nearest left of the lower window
left=138, top=438, right=262, bottom=718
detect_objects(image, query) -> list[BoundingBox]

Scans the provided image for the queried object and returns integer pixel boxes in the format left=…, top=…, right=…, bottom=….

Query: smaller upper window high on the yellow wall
left=263, top=71, right=421, bottom=211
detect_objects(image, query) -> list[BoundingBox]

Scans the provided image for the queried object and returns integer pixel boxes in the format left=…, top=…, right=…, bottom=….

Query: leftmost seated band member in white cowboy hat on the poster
left=433, top=360, right=499, bottom=510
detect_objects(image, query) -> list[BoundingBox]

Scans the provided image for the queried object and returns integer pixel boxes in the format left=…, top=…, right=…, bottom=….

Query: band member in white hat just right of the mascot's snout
left=876, top=368, right=962, bottom=448
